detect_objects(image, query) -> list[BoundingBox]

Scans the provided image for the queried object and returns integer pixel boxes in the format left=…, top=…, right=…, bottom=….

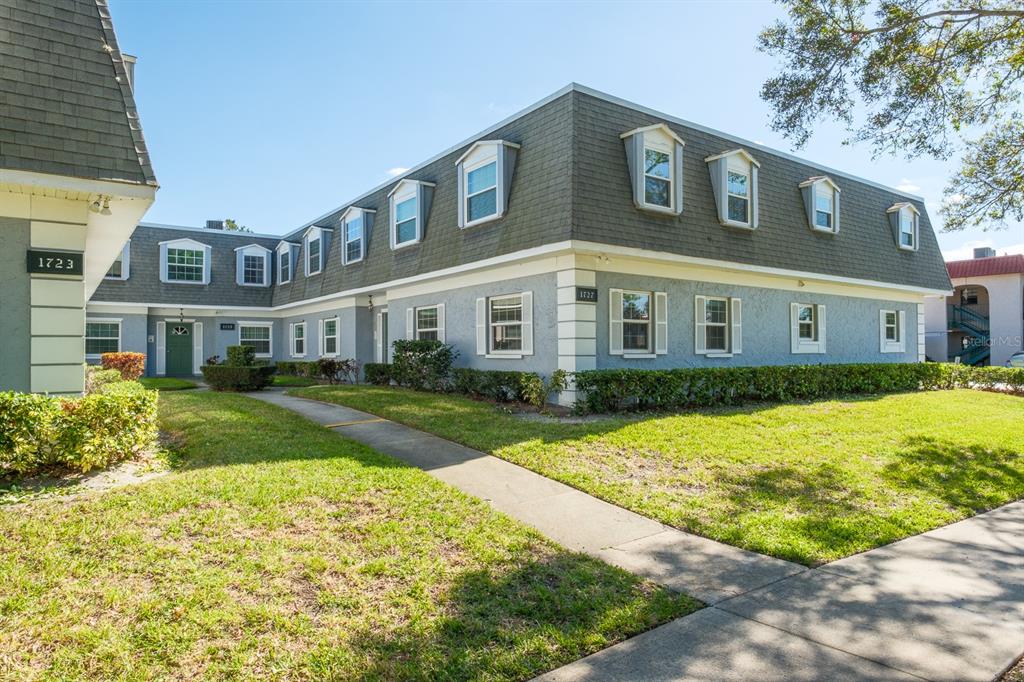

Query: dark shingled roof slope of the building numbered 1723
left=0, top=0, right=156, bottom=183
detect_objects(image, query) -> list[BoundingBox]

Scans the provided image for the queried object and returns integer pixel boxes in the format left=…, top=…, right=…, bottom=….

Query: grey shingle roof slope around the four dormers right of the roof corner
left=572, top=92, right=949, bottom=290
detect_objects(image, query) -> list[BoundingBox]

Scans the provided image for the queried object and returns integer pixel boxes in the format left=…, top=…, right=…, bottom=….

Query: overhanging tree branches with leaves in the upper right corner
left=759, top=0, right=1024, bottom=230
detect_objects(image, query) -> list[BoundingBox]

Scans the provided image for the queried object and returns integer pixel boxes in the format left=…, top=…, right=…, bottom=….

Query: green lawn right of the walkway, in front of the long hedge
left=292, top=386, right=1024, bottom=565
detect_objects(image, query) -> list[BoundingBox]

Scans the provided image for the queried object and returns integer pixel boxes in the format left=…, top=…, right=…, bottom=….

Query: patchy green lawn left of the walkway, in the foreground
left=0, top=392, right=697, bottom=680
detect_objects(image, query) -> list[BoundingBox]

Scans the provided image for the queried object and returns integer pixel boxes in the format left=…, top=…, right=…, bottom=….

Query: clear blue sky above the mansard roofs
left=111, top=0, right=1024, bottom=257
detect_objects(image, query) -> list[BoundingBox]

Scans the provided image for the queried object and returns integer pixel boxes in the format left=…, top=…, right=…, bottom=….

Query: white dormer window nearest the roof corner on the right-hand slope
left=620, top=123, right=684, bottom=215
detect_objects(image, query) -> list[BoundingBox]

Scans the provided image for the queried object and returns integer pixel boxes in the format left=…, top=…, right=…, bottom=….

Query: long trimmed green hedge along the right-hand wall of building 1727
left=575, top=363, right=1024, bottom=412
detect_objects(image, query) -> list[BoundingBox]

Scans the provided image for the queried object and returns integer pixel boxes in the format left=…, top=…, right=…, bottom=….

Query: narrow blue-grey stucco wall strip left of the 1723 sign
left=0, top=217, right=32, bottom=391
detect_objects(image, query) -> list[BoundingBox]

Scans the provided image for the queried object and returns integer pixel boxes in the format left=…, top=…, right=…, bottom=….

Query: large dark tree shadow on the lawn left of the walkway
left=311, top=552, right=699, bottom=680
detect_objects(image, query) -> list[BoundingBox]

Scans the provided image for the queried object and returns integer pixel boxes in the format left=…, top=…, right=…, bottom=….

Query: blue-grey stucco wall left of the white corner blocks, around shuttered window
left=388, top=273, right=558, bottom=375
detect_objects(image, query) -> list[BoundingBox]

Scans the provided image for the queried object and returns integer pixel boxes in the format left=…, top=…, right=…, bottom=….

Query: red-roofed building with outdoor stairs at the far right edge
left=925, top=248, right=1024, bottom=367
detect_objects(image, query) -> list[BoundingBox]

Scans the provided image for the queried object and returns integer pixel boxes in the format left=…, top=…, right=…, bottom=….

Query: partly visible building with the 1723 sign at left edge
left=0, top=0, right=157, bottom=393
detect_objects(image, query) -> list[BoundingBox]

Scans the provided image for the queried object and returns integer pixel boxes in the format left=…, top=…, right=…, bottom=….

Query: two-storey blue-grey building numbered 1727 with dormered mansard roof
left=87, top=85, right=950, bottom=401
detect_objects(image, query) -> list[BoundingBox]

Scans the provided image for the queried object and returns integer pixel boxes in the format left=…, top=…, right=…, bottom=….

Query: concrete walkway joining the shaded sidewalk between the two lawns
left=251, top=391, right=1024, bottom=682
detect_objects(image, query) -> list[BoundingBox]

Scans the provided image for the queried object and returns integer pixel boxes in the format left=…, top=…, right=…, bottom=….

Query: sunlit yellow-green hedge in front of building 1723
left=0, top=381, right=157, bottom=475
